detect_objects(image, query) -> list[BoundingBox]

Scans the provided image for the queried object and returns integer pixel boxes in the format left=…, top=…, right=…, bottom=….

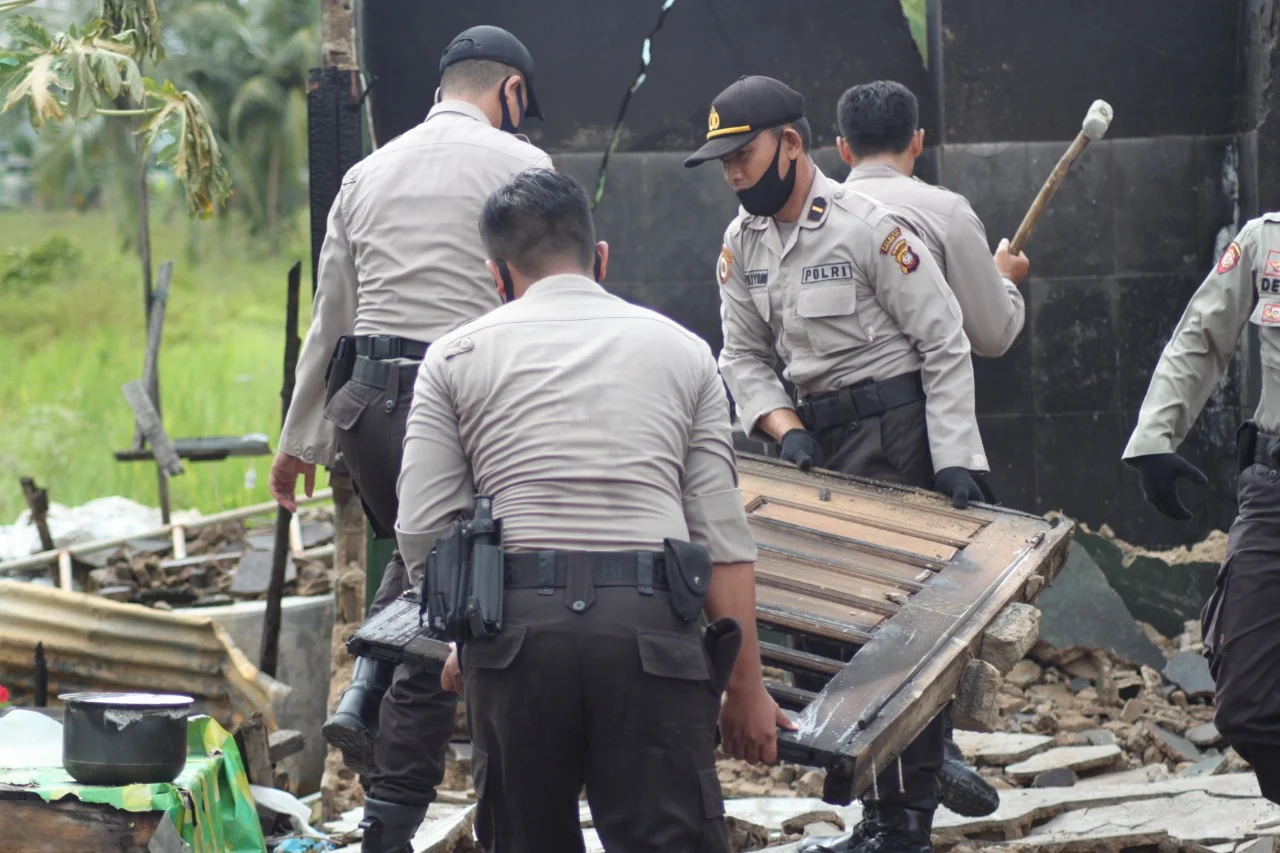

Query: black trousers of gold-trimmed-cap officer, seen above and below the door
left=797, top=401, right=946, bottom=808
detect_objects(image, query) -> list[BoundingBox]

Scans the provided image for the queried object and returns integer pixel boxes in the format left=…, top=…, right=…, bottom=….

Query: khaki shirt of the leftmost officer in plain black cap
left=280, top=101, right=552, bottom=465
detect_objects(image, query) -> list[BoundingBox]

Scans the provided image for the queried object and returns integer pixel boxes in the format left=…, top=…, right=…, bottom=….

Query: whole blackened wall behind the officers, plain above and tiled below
left=353, top=0, right=1280, bottom=546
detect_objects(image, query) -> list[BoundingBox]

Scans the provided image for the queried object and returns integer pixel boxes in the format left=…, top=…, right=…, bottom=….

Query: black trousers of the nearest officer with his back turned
left=462, top=584, right=730, bottom=853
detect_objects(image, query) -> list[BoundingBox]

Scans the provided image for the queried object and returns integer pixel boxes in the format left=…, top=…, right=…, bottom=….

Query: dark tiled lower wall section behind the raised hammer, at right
left=942, top=136, right=1245, bottom=544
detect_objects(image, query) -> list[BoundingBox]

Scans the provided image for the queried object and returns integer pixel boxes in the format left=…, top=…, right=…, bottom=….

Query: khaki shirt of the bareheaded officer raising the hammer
left=845, top=163, right=1027, bottom=357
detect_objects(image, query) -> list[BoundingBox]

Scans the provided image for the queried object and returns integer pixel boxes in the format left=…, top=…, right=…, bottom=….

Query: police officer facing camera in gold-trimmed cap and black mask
left=685, top=77, right=987, bottom=853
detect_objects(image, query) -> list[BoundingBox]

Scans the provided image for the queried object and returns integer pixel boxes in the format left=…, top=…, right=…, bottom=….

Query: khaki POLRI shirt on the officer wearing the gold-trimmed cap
left=717, top=166, right=988, bottom=471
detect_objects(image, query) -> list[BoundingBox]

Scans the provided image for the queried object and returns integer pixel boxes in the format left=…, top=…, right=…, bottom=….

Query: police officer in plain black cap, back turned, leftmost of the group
left=264, top=27, right=550, bottom=853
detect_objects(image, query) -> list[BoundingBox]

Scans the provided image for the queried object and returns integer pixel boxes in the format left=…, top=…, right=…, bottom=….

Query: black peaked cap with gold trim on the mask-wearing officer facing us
left=685, top=77, right=804, bottom=168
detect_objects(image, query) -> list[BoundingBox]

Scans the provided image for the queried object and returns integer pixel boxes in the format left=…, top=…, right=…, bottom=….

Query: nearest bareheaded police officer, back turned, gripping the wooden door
left=397, top=170, right=790, bottom=853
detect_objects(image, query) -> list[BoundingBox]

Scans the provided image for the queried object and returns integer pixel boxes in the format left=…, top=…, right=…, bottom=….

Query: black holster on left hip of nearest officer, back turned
left=421, top=494, right=504, bottom=643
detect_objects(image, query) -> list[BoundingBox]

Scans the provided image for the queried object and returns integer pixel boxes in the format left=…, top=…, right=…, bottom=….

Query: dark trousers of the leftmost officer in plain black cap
left=325, top=369, right=458, bottom=806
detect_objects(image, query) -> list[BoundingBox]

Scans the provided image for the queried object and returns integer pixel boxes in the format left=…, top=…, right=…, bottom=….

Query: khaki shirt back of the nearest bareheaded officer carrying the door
left=396, top=275, right=755, bottom=567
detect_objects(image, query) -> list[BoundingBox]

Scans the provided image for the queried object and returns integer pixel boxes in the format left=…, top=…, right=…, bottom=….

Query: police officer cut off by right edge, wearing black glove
left=1124, top=213, right=1280, bottom=803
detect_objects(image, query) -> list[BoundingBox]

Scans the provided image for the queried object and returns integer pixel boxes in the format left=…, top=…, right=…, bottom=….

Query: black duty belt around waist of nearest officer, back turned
left=506, top=551, right=669, bottom=594
